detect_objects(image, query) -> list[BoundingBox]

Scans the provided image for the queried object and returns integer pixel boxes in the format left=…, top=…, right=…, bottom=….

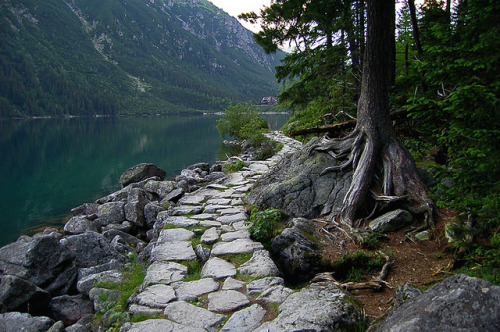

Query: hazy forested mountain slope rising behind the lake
left=0, top=0, right=283, bottom=117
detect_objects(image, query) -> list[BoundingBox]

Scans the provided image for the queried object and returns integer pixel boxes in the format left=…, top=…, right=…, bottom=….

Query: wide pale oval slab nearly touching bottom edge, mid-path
left=165, top=301, right=226, bottom=329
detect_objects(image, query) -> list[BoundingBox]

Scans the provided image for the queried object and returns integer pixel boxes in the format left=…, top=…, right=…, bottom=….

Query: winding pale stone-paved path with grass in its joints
left=124, top=132, right=302, bottom=332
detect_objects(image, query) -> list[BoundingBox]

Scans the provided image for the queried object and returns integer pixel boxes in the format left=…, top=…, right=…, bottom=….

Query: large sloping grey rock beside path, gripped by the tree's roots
left=247, top=138, right=352, bottom=218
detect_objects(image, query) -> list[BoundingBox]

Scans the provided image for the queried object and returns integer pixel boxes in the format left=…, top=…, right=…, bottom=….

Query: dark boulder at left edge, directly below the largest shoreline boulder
left=0, top=275, right=50, bottom=315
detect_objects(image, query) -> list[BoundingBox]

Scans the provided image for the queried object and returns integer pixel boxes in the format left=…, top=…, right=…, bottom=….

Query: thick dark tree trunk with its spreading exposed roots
left=315, top=0, right=434, bottom=225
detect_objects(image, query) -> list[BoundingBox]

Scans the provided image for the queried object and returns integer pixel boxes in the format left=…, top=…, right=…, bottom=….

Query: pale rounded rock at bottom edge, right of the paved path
left=255, top=283, right=364, bottom=332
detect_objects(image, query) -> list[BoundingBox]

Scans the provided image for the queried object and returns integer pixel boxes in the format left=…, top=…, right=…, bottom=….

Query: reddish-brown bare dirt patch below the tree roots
left=318, top=210, right=455, bottom=321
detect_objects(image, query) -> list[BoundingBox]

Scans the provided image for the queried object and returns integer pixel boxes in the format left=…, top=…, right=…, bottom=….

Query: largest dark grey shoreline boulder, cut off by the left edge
left=0, top=235, right=76, bottom=292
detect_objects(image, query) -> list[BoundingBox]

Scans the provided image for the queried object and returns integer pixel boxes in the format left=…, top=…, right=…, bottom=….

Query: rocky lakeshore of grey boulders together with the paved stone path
left=0, top=132, right=500, bottom=331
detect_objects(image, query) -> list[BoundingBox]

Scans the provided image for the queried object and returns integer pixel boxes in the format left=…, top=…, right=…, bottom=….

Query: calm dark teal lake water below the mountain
left=0, top=115, right=287, bottom=246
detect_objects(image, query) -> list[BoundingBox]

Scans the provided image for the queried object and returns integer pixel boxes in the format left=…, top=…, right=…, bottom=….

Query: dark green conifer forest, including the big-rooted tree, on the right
left=240, top=0, right=500, bottom=283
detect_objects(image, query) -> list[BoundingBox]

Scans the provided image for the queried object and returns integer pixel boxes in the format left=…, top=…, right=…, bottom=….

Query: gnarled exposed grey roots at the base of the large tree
left=309, top=128, right=434, bottom=228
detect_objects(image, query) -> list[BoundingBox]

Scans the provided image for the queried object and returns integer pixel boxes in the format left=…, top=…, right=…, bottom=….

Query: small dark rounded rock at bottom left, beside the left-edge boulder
left=49, top=295, right=93, bottom=325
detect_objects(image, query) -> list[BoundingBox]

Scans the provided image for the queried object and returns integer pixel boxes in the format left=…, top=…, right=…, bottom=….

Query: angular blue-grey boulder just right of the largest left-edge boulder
left=61, top=232, right=125, bottom=268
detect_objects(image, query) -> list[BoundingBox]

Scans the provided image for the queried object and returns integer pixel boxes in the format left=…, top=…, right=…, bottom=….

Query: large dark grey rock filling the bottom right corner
left=370, top=274, right=500, bottom=332
